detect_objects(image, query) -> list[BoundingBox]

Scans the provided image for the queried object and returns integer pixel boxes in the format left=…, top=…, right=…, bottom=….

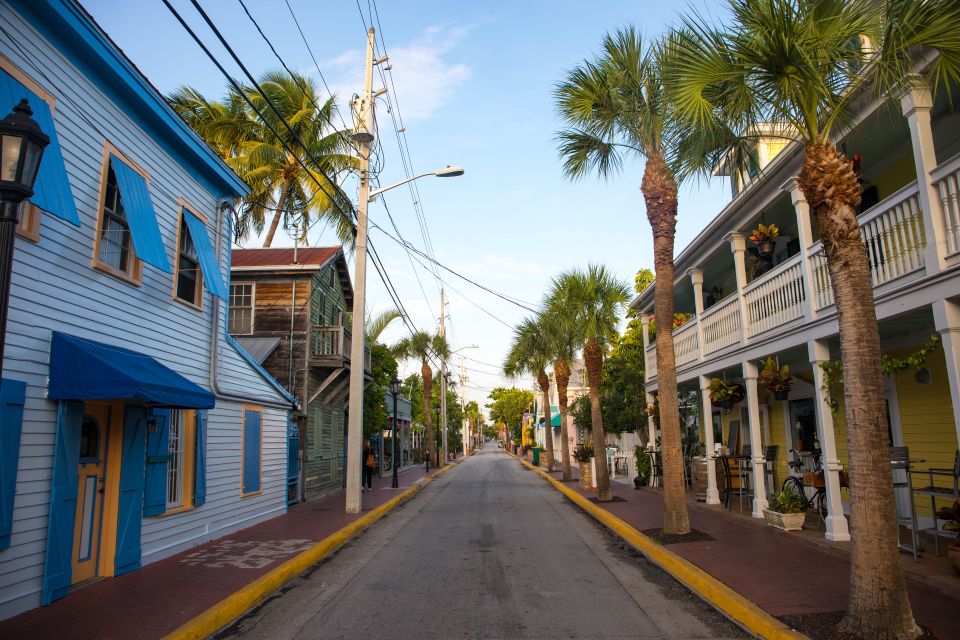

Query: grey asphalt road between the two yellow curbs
left=220, top=444, right=746, bottom=640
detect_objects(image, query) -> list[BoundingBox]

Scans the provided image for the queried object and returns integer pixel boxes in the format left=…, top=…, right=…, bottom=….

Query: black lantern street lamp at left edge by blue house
left=0, top=98, right=50, bottom=374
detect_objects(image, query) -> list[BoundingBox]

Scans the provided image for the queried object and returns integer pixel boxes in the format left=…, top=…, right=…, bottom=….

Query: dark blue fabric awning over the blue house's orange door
left=47, top=331, right=215, bottom=409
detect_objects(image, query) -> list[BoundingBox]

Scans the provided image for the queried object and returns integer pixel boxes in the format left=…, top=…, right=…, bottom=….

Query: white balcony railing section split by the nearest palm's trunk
left=808, top=182, right=926, bottom=309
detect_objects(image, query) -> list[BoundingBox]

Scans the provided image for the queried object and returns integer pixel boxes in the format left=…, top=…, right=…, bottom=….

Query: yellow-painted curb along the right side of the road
left=520, top=460, right=809, bottom=640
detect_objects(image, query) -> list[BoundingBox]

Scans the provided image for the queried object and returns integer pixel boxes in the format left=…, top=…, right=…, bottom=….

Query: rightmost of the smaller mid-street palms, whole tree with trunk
left=550, top=264, right=632, bottom=502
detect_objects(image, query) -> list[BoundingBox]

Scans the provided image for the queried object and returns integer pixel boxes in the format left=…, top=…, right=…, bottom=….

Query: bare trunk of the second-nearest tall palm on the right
left=640, top=154, right=690, bottom=535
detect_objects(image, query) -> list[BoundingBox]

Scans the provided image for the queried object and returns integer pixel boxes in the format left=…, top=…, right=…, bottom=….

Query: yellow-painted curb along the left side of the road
left=163, top=463, right=459, bottom=640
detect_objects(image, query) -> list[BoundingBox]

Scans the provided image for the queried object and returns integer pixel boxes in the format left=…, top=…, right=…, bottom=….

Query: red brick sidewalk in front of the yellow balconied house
left=536, top=460, right=960, bottom=640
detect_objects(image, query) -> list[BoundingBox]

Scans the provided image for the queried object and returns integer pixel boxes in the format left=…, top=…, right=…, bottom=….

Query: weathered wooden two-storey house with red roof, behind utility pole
left=230, top=247, right=370, bottom=500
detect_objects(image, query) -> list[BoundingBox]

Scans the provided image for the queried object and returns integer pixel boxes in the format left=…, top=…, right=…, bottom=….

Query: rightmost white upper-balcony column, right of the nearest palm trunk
left=900, top=74, right=947, bottom=274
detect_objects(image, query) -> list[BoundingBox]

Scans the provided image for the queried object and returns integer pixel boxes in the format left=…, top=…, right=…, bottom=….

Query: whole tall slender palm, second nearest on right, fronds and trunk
left=554, top=28, right=690, bottom=534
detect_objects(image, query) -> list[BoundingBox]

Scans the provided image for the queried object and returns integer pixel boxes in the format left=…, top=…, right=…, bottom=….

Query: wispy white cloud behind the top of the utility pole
left=321, top=25, right=472, bottom=124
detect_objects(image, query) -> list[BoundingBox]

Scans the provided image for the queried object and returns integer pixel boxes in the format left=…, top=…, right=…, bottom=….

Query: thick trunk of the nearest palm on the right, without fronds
left=798, top=143, right=920, bottom=640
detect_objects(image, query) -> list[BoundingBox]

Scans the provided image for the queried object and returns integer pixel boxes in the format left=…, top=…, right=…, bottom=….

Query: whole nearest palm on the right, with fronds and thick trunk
left=657, top=0, right=960, bottom=639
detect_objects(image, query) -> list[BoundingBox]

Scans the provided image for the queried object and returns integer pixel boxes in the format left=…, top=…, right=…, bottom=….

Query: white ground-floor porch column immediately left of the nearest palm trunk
left=807, top=340, right=850, bottom=542
